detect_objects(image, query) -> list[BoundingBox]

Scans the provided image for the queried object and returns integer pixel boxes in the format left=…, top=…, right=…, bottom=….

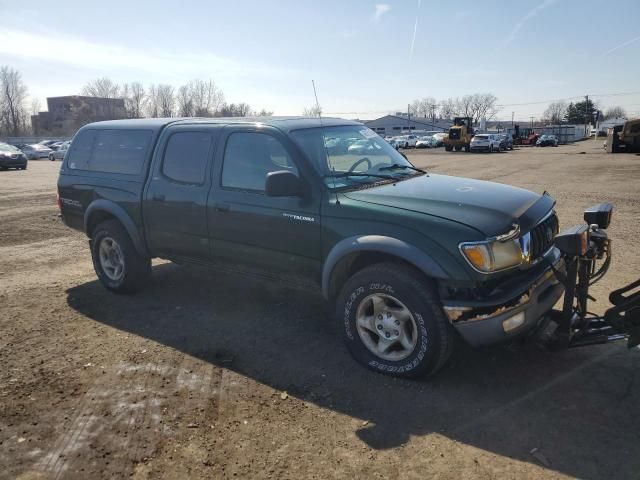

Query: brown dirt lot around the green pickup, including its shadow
left=0, top=142, right=640, bottom=479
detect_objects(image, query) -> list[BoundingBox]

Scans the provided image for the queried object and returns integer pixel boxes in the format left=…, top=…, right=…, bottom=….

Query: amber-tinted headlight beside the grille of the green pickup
left=460, top=239, right=524, bottom=273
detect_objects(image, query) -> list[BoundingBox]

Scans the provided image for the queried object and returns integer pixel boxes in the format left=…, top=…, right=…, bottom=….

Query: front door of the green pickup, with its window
left=208, top=126, right=321, bottom=276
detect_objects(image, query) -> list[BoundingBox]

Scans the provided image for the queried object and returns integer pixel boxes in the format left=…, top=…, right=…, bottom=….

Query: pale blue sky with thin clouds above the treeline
left=0, top=0, right=640, bottom=120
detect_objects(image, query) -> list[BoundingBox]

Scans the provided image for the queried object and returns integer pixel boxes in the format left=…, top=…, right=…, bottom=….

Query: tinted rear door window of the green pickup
left=162, top=132, right=213, bottom=185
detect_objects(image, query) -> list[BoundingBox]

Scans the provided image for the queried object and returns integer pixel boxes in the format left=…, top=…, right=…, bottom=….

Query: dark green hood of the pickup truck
left=344, top=174, right=554, bottom=237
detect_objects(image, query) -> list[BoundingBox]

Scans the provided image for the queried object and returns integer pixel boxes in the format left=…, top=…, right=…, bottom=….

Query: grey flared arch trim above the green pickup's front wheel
left=322, top=235, right=449, bottom=299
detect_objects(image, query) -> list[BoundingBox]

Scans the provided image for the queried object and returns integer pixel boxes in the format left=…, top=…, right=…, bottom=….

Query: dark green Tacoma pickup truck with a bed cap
left=58, top=117, right=564, bottom=377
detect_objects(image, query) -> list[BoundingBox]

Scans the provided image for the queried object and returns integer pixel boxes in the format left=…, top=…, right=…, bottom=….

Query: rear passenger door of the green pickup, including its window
left=144, top=125, right=219, bottom=259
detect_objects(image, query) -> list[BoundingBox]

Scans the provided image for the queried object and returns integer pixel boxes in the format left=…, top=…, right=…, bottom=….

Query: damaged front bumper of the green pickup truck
left=444, top=253, right=564, bottom=346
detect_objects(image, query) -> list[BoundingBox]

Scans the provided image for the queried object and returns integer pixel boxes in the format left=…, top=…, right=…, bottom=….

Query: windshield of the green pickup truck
left=292, top=125, right=420, bottom=189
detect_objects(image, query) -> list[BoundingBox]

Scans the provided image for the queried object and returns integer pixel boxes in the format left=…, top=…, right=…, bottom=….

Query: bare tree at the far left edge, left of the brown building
left=0, top=66, right=27, bottom=136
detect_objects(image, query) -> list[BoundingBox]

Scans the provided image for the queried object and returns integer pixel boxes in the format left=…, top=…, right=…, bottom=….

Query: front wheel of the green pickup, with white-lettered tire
left=336, top=263, right=453, bottom=378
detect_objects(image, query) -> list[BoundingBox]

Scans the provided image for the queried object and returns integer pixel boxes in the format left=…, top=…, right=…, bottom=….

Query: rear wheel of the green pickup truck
left=91, top=220, right=151, bottom=293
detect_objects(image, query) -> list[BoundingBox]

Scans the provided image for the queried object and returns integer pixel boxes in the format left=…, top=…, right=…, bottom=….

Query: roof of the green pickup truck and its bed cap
left=84, top=117, right=362, bottom=132
